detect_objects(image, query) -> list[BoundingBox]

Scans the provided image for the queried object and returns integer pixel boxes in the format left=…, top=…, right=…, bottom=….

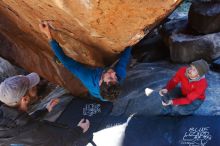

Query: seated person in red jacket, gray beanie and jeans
left=159, top=59, right=209, bottom=115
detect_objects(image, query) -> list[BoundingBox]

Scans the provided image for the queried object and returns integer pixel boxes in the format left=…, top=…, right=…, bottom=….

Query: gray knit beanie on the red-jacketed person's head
left=191, top=59, right=209, bottom=77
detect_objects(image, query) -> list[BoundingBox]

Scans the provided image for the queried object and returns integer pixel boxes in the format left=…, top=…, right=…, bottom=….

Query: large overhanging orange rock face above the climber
left=0, top=0, right=181, bottom=96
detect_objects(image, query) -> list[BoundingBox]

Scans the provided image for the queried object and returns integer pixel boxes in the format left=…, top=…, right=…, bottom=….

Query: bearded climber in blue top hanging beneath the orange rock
left=39, top=21, right=131, bottom=101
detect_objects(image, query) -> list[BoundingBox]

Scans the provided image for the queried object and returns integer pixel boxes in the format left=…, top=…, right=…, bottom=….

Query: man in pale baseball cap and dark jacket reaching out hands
left=0, top=73, right=90, bottom=146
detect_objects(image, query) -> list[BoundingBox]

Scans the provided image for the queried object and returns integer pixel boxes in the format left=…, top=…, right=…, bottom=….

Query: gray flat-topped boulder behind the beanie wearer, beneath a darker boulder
left=169, top=33, right=220, bottom=63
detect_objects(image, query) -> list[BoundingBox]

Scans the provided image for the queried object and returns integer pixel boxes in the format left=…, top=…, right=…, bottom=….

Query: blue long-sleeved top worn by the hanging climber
left=49, top=40, right=131, bottom=101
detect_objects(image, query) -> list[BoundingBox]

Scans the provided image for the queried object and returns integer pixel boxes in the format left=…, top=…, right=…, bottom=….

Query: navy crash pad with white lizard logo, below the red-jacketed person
left=123, top=116, right=220, bottom=146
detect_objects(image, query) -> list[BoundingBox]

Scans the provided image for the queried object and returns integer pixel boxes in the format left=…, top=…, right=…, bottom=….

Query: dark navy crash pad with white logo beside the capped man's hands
left=56, top=99, right=113, bottom=135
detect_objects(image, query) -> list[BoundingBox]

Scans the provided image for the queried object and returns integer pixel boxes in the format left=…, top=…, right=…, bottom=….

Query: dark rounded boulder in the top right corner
left=189, top=1, right=220, bottom=34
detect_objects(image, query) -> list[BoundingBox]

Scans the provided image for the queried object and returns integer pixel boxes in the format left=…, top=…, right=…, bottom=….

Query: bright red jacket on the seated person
left=166, top=67, right=208, bottom=105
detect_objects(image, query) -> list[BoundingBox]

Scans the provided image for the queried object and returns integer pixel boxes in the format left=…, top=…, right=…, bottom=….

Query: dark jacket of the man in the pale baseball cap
left=0, top=105, right=82, bottom=146
